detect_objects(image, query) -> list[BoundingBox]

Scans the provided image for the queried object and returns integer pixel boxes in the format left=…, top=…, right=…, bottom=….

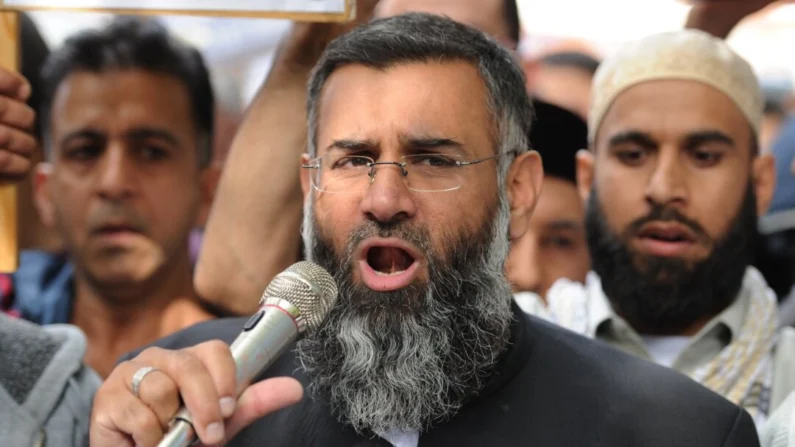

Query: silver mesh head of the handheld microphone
left=260, top=261, right=338, bottom=332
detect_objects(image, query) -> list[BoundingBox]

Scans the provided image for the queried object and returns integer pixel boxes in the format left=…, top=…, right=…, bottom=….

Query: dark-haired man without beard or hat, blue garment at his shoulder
left=3, top=18, right=218, bottom=376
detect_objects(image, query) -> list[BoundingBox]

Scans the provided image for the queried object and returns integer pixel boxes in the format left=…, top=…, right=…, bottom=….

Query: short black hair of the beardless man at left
left=39, top=17, right=215, bottom=167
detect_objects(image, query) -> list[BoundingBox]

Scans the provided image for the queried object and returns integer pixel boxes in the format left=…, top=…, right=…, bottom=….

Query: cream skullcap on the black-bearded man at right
left=588, top=30, right=764, bottom=143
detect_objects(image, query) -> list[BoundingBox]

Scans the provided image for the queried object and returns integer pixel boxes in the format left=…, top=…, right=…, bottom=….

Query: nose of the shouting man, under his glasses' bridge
left=361, top=161, right=417, bottom=223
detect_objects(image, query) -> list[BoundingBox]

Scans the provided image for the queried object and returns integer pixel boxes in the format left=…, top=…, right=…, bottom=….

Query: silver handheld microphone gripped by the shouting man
left=158, top=261, right=337, bottom=447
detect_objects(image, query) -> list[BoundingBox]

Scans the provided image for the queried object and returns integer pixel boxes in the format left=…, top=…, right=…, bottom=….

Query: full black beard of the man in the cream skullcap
left=585, top=186, right=758, bottom=335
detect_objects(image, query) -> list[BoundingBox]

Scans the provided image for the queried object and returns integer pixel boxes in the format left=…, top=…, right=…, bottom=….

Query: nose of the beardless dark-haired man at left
left=97, top=142, right=137, bottom=202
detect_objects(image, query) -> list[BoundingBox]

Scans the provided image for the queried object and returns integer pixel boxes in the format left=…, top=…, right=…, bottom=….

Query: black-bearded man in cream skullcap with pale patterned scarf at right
left=547, top=30, right=795, bottom=424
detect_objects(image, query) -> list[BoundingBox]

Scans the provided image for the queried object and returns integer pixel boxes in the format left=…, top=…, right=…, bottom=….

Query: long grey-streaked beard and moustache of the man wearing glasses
left=298, top=195, right=513, bottom=434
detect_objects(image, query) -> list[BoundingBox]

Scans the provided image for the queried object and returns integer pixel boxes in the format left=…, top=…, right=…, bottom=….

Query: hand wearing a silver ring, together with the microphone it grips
left=91, top=262, right=338, bottom=447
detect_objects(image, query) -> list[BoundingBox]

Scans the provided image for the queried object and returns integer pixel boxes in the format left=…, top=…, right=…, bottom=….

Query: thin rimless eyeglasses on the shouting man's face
left=303, top=151, right=516, bottom=193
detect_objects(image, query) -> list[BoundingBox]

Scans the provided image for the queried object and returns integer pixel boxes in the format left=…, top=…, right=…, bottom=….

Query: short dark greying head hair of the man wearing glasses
left=307, top=13, right=533, bottom=184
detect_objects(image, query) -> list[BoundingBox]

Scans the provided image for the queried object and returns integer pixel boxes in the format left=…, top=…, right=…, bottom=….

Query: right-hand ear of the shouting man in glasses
left=505, top=151, right=544, bottom=240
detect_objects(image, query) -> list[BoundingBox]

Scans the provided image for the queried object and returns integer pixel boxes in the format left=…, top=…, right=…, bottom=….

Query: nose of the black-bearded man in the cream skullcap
left=645, top=149, right=687, bottom=206
